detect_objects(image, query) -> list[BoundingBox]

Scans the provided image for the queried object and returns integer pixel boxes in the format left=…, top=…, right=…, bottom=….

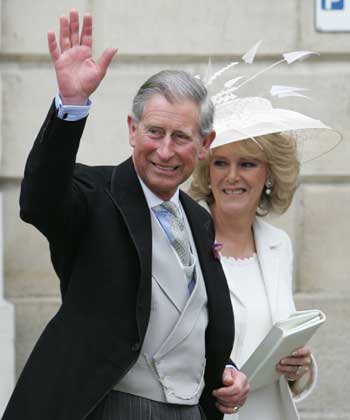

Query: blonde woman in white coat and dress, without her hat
left=190, top=133, right=316, bottom=420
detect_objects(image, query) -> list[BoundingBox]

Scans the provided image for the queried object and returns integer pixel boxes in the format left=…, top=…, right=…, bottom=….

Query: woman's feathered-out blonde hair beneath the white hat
left=189, top=133, right=300, bottom=216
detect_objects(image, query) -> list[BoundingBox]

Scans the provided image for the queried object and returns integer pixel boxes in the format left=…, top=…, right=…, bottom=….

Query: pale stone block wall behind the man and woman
left=0, top=0, right=350, bottom=420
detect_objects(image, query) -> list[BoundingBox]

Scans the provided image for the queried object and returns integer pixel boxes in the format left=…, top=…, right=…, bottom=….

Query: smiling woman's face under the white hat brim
left=210, top=142, right=267, bottom=216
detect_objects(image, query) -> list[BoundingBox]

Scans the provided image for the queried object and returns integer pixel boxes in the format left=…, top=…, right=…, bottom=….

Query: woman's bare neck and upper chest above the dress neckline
left=210, top=203, right=255, bottom=259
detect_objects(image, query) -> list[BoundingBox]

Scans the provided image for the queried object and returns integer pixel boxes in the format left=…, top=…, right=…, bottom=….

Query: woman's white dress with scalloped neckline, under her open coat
left=221, top=254, right=284, bottom=420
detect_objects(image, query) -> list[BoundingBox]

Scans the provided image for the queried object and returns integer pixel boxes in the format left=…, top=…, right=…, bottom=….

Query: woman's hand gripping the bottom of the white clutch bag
left=276, top=346, right=311, bottom=381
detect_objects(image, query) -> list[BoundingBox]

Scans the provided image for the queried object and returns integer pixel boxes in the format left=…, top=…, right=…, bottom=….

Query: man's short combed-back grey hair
left=132, top=70, right=214, bottom=138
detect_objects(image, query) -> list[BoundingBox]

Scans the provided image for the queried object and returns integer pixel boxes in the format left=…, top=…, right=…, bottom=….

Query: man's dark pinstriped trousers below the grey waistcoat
left=86, top=391, right=205, bottom=420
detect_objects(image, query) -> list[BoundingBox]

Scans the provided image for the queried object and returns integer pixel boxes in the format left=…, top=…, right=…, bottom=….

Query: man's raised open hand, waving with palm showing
left=47, top=9, right=117, bottom=105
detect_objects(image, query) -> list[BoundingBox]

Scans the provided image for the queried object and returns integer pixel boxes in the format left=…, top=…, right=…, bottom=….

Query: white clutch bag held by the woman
left=240, top=309, right=326, bottom=390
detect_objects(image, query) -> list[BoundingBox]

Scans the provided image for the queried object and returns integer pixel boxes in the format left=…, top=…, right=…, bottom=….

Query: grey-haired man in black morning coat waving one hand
left=3, top=10, right=248, bottom=420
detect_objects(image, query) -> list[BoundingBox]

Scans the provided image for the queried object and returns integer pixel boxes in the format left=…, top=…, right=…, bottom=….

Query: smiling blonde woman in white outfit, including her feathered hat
left=189, top=41, right=341, bottom=420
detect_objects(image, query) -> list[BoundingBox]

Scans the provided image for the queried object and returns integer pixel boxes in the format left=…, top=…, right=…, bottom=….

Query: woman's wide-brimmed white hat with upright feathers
left=200, top=41, right=342, bottom=163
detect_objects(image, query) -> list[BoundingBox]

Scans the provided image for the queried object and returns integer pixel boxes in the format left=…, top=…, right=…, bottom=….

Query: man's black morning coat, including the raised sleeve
left=2, top=105, right=234, bottom=420
